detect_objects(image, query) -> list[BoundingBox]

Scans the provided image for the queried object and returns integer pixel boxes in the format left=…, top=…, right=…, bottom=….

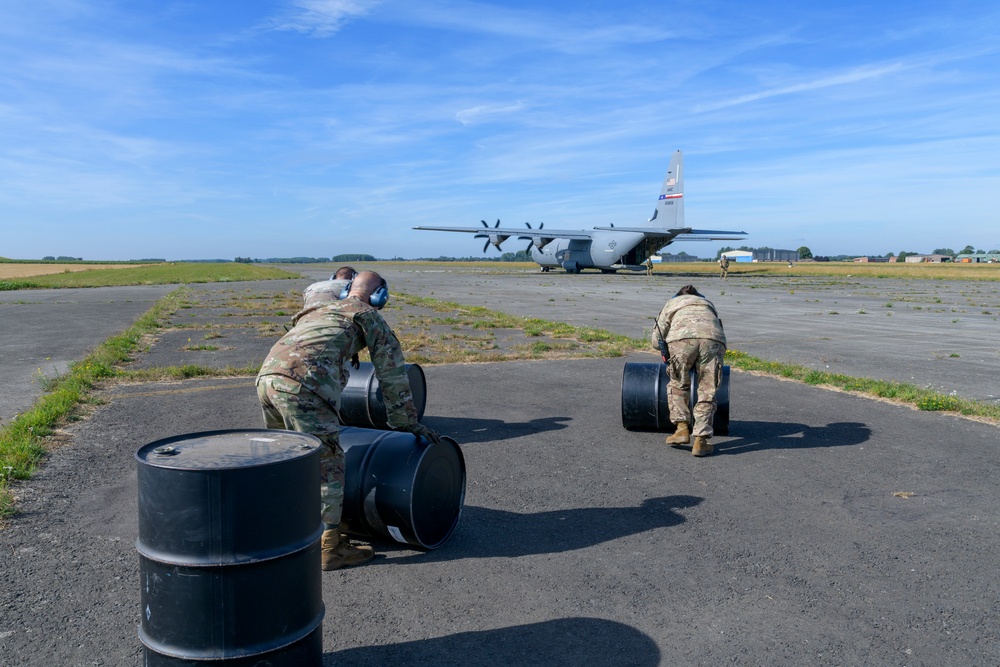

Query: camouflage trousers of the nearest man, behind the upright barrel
left=257, top=375, right=344, bottom=528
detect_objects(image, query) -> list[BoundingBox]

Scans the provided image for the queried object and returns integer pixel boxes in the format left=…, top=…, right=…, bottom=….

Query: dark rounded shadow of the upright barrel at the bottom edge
left=323, top=618, right=660, bottom=667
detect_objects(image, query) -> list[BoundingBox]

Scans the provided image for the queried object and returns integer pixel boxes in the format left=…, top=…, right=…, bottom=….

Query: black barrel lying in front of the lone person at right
left=622, top=362, right=729, bottom=435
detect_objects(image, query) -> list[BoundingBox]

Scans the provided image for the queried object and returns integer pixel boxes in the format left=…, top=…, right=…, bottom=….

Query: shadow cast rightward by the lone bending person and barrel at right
left=712, top=421, right=872, bottom=456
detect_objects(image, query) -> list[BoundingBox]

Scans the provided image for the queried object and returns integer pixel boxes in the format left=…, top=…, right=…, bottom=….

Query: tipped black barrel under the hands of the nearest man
left=340, top=426, right=465, bottom=549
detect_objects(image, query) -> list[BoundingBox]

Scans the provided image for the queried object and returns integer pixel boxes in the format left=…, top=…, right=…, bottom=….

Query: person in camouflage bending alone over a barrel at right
left=652, top=285, right=726, bottom=456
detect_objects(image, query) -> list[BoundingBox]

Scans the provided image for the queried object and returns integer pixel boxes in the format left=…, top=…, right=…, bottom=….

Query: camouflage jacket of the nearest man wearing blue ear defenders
left=257, top=297, right=417, bottom=428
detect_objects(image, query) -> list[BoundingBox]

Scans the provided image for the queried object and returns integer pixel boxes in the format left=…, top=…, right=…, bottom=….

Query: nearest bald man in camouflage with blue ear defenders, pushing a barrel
left=257, top=271, right=440, bottom=570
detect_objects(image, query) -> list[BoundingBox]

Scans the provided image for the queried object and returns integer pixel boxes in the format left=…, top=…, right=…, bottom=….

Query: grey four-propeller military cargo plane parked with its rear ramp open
left=413, top=151, right=746, bottom=273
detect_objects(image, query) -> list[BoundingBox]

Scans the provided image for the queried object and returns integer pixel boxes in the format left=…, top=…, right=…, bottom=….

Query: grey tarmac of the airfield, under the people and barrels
left=0, top=269, right=1000, bottom=667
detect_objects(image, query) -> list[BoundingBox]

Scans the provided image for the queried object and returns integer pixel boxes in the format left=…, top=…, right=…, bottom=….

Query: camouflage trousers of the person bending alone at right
left=667, top=338, right=726, bottom=438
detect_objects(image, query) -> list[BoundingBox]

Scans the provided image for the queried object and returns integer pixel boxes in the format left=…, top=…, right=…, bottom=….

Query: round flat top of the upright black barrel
left=135, top=429, right=323, bottom=470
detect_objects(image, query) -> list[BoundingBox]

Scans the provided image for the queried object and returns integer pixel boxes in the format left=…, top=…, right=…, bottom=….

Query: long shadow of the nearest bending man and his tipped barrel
left=372, top=496, right=703, bottom=565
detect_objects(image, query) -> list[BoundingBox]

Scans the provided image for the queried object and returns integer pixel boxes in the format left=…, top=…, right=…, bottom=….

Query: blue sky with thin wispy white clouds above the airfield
left=0, top=0, right=1000, bottom=259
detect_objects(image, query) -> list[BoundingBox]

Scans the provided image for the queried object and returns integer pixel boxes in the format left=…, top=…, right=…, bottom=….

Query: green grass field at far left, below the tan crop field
left=0, top=262, right=301, bottom=290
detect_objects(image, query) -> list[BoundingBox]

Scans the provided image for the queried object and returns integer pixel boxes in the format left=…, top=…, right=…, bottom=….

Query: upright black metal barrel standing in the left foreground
left=135, top=429, right=324, bottom=667
